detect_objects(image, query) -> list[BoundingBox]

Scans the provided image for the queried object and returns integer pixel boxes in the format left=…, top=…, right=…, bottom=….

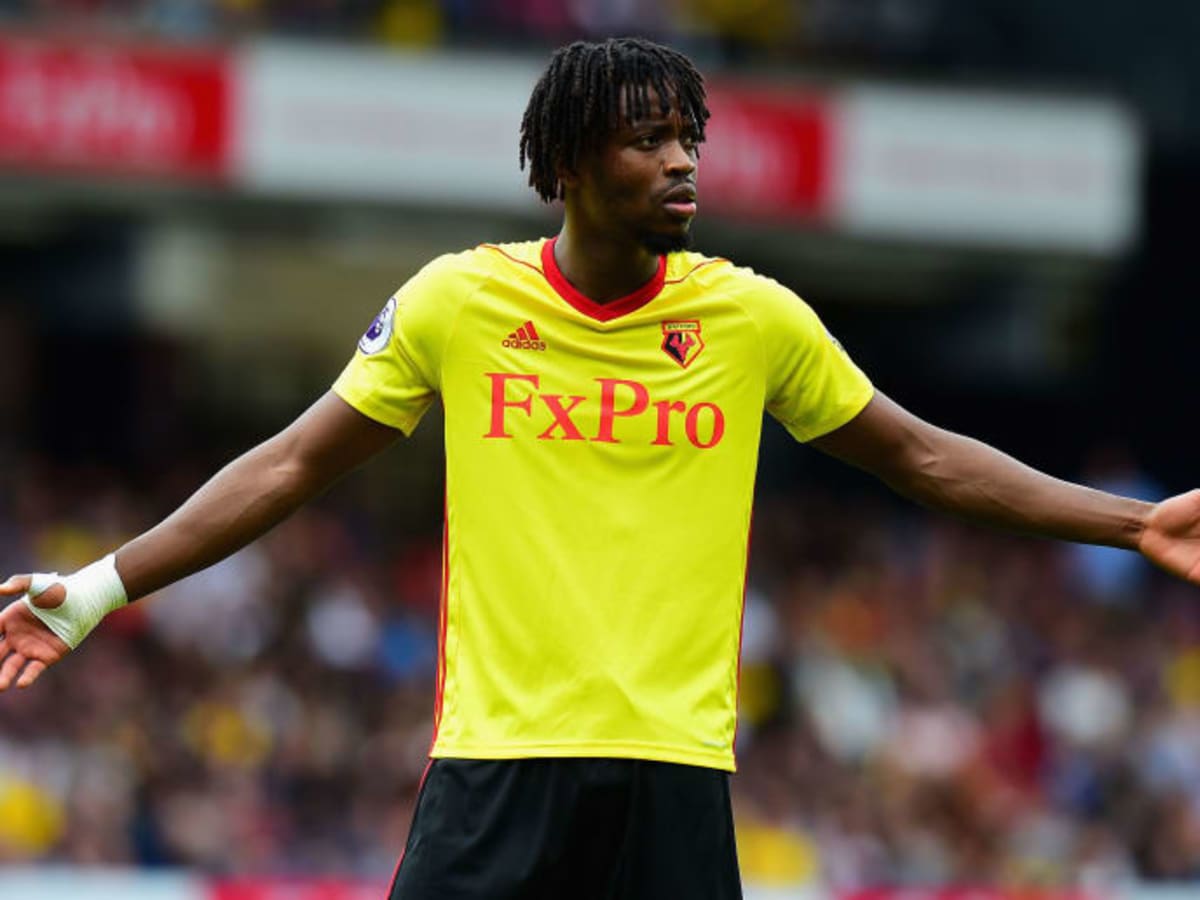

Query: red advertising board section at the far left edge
left=0, top=38, right=232, bottom=179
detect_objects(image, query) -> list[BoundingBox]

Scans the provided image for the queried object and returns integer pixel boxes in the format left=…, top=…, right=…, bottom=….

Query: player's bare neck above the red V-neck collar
left=554, top=222, right=659, bottom=304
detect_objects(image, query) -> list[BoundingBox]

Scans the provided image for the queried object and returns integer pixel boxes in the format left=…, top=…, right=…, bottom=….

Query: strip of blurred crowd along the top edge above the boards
left=0, top=0, right=947, bottom=60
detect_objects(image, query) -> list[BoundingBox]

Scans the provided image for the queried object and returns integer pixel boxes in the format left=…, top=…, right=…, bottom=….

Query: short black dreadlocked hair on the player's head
left=521, top=37, right=709, bottom=203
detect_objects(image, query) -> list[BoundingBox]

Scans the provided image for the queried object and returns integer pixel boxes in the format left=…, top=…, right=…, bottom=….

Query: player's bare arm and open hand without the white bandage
left=811, top=392, right=1200, bottom=583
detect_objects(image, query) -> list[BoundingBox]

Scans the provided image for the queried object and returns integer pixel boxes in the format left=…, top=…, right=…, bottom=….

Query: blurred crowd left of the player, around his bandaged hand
left=0, top=453, right=440, bottom=876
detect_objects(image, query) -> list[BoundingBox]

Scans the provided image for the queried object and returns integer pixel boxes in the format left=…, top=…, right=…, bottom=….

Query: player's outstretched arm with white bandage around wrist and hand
left=0, top=394, right=400, bottom=691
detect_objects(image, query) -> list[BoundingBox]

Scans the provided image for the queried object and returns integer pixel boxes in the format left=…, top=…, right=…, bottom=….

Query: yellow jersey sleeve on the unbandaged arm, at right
left=755, top=278, right=875, bottom=442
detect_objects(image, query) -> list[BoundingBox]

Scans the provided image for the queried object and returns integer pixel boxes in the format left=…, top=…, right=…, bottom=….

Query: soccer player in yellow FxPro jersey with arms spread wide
left=0, top=38, right=1200, bottom=900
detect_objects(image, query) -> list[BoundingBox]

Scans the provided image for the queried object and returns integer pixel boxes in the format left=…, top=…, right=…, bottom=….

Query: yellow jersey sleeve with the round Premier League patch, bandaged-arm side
left=332, top=257, right=464, bottom=434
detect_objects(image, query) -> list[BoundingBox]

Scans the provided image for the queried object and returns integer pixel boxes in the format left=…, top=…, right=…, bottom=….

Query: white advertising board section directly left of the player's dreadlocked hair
left=233, top=43, right=539, bottom=209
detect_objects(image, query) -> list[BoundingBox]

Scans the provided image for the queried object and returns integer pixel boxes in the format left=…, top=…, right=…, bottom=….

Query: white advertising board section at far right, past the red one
left=833, top=86, right=1140, bottom=254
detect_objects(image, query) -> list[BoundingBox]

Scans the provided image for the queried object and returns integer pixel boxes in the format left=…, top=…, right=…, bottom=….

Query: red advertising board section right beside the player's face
left=700, top=84, right=833, bottom=220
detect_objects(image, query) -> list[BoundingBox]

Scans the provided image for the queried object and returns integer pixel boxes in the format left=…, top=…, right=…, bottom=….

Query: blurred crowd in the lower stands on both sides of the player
left=0, top=458, right=1200, bottom=888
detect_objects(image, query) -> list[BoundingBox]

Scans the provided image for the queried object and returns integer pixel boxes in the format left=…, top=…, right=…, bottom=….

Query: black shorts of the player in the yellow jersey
left=389, top=758, right=742, bottom=900
